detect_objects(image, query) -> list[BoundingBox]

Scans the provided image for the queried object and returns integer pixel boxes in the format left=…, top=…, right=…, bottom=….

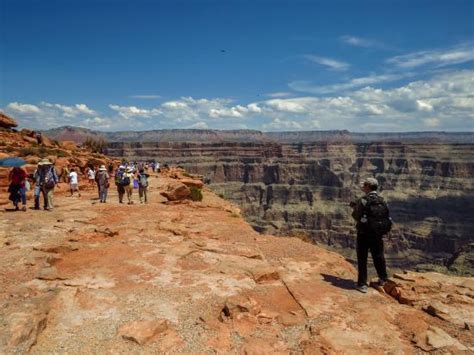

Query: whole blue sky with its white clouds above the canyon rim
left=0, top=0, right=474, bottom=132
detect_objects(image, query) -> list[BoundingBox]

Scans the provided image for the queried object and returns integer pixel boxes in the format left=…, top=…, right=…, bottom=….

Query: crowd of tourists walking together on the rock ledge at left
left=8, top=159, right=160, bottom=211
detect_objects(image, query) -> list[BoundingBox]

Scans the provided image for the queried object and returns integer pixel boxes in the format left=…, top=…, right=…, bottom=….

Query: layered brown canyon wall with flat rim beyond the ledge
left=45, top=127, right=474, bottom=276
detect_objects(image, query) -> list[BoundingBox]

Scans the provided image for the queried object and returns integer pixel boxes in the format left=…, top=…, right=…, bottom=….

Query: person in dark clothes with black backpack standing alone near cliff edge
left=351, top=178, right=392, bottom=293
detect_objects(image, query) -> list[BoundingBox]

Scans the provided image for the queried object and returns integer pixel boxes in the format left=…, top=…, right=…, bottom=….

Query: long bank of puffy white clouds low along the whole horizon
left=2, top=69, right=474, bottom=132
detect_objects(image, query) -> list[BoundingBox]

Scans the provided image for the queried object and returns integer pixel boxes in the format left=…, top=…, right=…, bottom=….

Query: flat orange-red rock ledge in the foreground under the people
left=0, top=174, right=474, bottom=354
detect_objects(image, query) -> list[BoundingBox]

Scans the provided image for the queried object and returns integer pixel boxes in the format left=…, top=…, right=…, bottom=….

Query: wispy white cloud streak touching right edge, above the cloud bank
left=387, top=42, right=474, bottom=69
